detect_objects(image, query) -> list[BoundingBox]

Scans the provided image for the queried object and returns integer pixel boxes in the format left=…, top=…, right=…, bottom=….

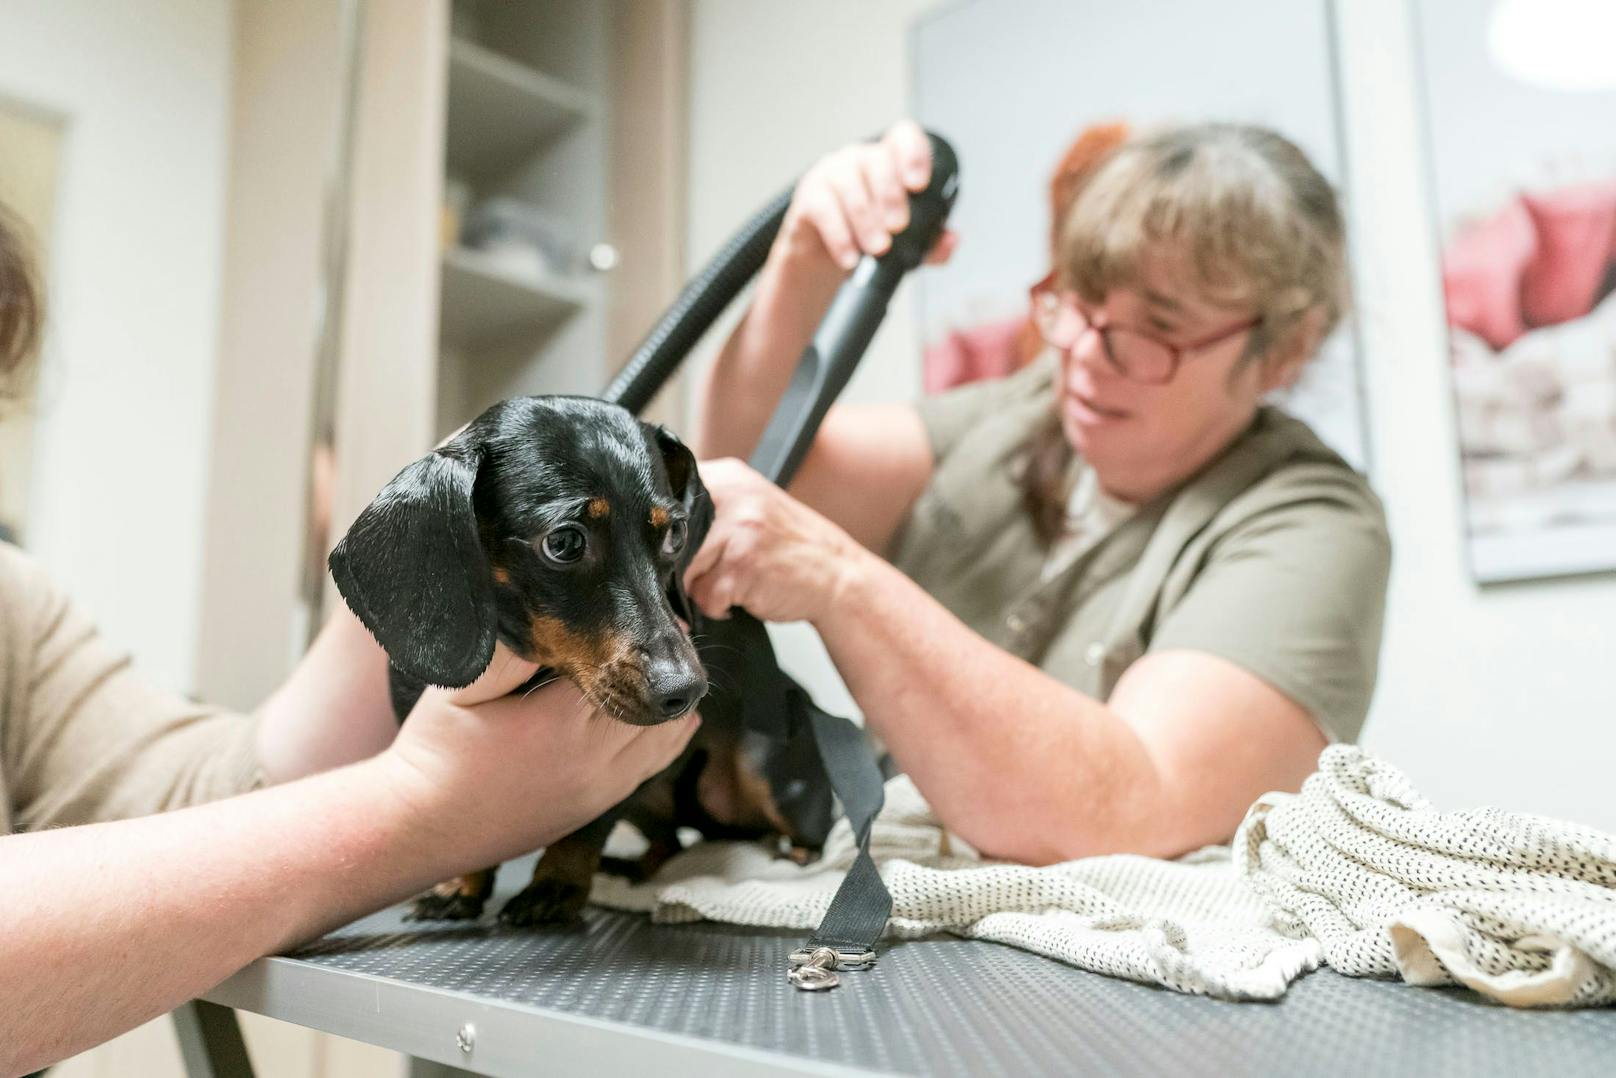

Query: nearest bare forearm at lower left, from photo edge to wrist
left=0, top=758, right=462, bottom=1075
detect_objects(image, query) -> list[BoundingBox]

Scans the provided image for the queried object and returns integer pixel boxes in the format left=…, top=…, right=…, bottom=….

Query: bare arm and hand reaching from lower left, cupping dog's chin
left=0, top=653, right=696, bottom=1073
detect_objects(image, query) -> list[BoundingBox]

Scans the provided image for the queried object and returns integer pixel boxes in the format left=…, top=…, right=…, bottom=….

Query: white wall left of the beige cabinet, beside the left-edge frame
left=0, top=0, right=233, bottom=688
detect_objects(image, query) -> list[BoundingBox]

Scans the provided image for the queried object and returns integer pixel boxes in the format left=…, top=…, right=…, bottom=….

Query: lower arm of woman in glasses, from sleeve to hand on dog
left=685, top=461, right=1324, bottom=863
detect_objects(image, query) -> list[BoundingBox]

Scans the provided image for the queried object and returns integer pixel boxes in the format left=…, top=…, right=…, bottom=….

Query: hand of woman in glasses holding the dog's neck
left=685, top=459, right=874, bottom=622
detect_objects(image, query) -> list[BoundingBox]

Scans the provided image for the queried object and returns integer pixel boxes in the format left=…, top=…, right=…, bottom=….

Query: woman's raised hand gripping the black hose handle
left=781, top=120, right=958, bottom=273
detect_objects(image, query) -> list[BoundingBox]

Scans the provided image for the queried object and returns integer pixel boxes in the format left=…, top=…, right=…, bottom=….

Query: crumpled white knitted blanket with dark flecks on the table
left=591, top=745, right=1616, bottom=1007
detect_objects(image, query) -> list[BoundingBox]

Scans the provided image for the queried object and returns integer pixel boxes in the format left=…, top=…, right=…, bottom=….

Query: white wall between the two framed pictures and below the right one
left=1338, top=0, right=1616, bottom=829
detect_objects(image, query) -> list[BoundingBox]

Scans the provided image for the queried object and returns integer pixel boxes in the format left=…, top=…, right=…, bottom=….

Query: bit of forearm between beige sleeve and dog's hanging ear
left=257, top=608, right=398, bottom=782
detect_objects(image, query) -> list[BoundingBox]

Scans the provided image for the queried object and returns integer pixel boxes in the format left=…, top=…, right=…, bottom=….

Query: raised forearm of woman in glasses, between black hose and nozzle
left=693, top=236, right=845, bottom=459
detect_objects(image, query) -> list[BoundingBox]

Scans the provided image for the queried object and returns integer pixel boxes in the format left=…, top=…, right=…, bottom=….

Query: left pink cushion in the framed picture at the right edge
left=1441, top=199, right=1537, bottom=349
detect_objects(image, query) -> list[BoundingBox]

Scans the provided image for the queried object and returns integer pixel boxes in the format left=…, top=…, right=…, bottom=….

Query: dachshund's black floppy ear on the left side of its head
left=331, top=438, right=496, bottom=688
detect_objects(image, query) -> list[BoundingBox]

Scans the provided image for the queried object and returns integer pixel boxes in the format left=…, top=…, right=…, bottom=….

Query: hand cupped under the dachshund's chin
left=378, top=645, right=700, bottom=874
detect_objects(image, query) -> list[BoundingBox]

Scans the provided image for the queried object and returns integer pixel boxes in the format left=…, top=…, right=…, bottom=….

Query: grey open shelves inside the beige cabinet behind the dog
left=438, top=0, right=611, bottom=432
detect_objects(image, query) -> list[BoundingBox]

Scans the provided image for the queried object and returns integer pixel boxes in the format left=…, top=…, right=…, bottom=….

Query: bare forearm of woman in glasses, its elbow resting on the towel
left=816, top=556, right=1183, bottom=863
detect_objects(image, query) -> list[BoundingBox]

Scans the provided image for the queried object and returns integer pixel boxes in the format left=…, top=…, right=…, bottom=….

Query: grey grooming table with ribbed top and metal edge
left=189, top=866, right=1616, bottom=1078
